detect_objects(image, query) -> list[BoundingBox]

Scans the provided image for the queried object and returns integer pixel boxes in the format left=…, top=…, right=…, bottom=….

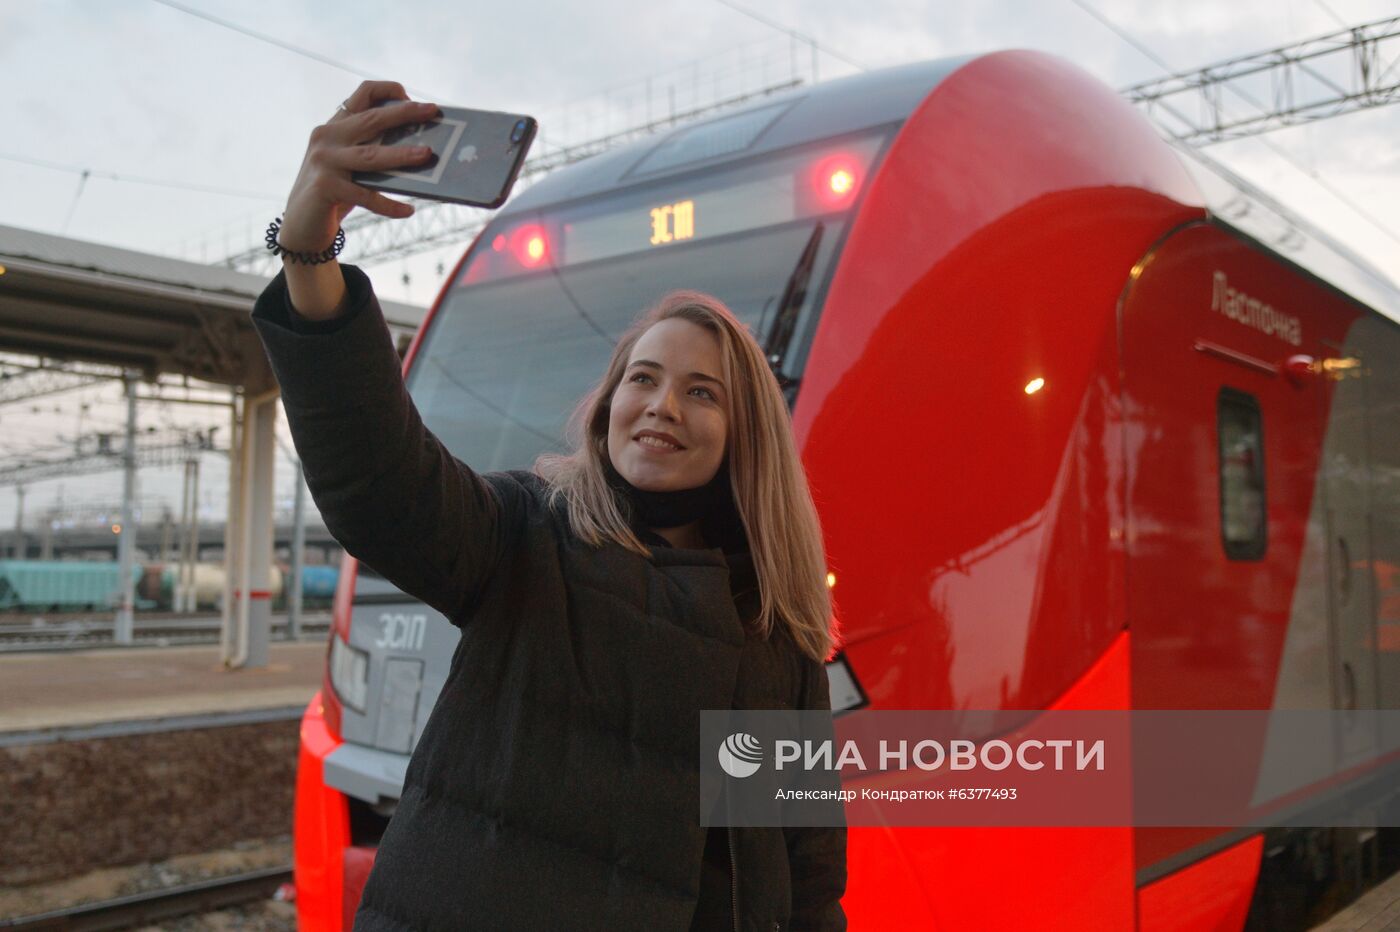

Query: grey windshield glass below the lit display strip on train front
left=409, top=216, right=844, bottom=472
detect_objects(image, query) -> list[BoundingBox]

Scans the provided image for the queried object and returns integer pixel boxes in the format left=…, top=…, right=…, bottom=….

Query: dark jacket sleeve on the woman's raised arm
left=252, top=266, right=525, bottom=624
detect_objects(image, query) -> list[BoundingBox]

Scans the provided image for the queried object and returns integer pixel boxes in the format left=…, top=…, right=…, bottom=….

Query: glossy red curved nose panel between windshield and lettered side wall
left=794, top=53, right=1201, bottom=929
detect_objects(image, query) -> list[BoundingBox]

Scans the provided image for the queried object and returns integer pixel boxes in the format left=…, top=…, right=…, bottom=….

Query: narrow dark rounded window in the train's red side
left=1215, top=388, right=1268, bottom=560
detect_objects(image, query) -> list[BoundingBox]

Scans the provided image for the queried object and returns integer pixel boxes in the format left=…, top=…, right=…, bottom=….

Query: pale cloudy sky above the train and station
left=0, top=0, right=1400, bottom=540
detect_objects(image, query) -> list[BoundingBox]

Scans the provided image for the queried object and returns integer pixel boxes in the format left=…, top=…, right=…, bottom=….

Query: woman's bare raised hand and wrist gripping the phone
left=277, top=81, right=438, bottom=320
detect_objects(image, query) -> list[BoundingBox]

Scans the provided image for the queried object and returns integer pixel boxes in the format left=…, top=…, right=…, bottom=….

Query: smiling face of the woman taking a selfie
left=608, top=318, right=729, bottom=491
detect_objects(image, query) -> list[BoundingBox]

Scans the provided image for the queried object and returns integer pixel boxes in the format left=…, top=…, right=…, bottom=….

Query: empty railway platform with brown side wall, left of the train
left=0, top=635, right=326, bottom=890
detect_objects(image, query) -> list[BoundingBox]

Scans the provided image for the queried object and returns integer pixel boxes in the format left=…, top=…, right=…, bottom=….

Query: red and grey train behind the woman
left=287, top=52, right=1400, bottom=929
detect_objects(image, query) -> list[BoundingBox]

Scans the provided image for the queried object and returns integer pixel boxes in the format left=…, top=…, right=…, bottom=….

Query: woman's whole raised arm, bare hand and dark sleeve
left=253, top=83, right=524, bottom=623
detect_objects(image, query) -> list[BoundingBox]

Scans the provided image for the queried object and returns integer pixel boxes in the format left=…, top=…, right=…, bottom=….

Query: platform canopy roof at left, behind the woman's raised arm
left=0, top=227, right=426, bottom=386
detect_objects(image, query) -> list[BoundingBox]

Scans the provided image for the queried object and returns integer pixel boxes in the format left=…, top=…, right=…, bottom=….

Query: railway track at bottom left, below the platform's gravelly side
left=0, top=866, right=291, bottom=932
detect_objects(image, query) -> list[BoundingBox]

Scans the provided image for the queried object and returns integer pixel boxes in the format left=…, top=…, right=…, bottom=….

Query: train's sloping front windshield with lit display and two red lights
left=409, top=130, right=881, bottom=472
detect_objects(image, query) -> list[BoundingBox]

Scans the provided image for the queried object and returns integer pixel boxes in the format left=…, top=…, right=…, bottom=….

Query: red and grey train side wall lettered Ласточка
left=1121, top=223, right=1400, bottom=928
